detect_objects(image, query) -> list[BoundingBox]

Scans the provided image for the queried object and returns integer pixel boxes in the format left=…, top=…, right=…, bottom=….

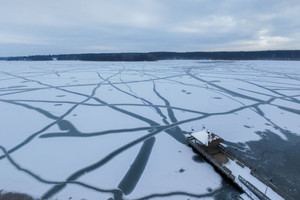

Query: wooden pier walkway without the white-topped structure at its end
left=187, top=136, right=293, bottom=200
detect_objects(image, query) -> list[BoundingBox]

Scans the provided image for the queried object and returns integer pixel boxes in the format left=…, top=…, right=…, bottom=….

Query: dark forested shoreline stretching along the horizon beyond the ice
left=0, top=50, right=300, bottom=61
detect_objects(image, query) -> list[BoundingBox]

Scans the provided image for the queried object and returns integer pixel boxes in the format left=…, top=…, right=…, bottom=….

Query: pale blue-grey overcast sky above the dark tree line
left=0, top=0, right=300, bottom=56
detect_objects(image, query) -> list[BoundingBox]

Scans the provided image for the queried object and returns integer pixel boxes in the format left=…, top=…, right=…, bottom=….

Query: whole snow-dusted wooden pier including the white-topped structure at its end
left=187, top=130, right=292, bottom=200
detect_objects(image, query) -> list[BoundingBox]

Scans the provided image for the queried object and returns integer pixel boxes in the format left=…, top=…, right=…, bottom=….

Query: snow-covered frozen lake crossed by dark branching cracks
left=0, top=60, right=300, bottom=200
